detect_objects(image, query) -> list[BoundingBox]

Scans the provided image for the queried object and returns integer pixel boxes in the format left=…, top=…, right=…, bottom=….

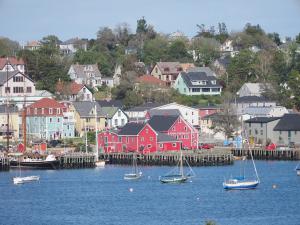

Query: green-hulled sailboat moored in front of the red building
left=159, top=150, right=195, bottom=183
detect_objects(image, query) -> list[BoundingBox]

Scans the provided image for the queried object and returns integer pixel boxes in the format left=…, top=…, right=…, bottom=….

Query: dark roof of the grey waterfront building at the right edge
left=274, top=114, right=300, bottom=131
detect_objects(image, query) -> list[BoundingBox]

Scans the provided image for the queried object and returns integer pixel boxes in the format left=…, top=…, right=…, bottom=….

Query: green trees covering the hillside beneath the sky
left=0, top=18, right=300, bottom=108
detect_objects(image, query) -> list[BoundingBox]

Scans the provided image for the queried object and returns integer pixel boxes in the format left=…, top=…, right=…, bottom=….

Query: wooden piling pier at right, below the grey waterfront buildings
left=231, top=148, right=300, bottom=160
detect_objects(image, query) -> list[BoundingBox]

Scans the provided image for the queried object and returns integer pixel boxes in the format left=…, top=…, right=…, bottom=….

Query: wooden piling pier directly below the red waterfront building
left=99, top=150, right=233, bottom=166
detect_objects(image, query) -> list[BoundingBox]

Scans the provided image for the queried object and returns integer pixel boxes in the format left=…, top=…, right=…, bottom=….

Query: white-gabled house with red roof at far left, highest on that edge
left=0, top=57, right=25, bottom=73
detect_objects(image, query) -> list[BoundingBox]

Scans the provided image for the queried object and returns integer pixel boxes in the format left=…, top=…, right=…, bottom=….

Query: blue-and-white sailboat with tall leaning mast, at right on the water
left=223, top=132, right=260, bottom=190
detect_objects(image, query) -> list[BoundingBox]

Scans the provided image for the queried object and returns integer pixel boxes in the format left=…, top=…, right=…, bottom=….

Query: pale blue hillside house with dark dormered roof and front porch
left=173, top=71, right=222, bottom=96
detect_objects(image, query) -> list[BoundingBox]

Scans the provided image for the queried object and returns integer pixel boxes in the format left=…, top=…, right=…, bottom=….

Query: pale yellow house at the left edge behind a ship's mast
left=0, top=105, right=21, bottom=142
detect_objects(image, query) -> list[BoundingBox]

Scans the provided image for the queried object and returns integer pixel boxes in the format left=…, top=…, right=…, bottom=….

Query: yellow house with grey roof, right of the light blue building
left=70, top=101, right=106, bottom=137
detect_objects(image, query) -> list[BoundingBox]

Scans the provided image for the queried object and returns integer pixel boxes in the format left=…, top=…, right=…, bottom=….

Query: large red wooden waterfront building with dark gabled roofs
left=98, top=116, right=198, bottom=153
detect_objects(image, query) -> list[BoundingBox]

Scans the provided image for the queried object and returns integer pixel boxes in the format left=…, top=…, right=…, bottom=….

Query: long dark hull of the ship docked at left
left=10, top=160, right=59, bottom=170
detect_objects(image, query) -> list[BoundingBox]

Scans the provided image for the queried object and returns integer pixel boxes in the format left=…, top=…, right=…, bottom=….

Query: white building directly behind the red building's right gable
left=154, top=102, right=200, bottom=127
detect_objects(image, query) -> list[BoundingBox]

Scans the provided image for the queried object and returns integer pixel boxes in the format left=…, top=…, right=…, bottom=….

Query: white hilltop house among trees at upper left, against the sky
left=59, top=38, right=88, bottom=55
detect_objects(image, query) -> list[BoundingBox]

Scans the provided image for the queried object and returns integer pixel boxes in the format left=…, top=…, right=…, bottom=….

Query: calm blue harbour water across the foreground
left=0, top=161, right=300, bottom=225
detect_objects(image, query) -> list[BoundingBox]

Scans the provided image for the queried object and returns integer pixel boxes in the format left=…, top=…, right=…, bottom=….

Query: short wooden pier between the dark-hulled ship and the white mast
left=59, top=153, right=96, bottom=169
